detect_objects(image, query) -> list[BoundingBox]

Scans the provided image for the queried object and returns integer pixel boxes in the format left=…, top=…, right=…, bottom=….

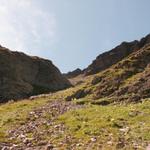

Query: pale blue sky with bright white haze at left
left=0, top=0, right=150, bottom=72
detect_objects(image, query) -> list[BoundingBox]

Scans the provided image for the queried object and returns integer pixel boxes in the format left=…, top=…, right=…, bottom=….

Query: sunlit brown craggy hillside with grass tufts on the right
left=66, top=39, right=150, bottom=102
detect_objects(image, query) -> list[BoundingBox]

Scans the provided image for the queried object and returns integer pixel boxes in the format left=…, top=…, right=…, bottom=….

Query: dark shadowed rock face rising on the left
left=0, top=47, right=71, bottom=102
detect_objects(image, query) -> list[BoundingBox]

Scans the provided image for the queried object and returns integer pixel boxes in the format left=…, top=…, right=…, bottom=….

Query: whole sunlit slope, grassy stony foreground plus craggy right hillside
left=0, top=34, right=150, bottom=150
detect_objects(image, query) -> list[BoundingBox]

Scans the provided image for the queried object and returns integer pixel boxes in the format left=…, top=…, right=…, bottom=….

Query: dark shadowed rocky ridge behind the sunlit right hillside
left=84, top=35, right=150, bottom=75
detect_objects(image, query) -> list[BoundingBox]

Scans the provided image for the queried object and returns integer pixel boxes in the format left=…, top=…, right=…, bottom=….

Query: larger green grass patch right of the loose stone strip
left=59, top=101, right=150, bottom=149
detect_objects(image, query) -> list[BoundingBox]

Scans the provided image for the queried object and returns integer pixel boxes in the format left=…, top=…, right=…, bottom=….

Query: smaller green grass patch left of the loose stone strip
left=0, top=98, right=47, bottom=142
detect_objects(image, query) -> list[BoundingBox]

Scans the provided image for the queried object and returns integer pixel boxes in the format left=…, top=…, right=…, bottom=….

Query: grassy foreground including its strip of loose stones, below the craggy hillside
left=0, top=94, right=150, bottom=150
